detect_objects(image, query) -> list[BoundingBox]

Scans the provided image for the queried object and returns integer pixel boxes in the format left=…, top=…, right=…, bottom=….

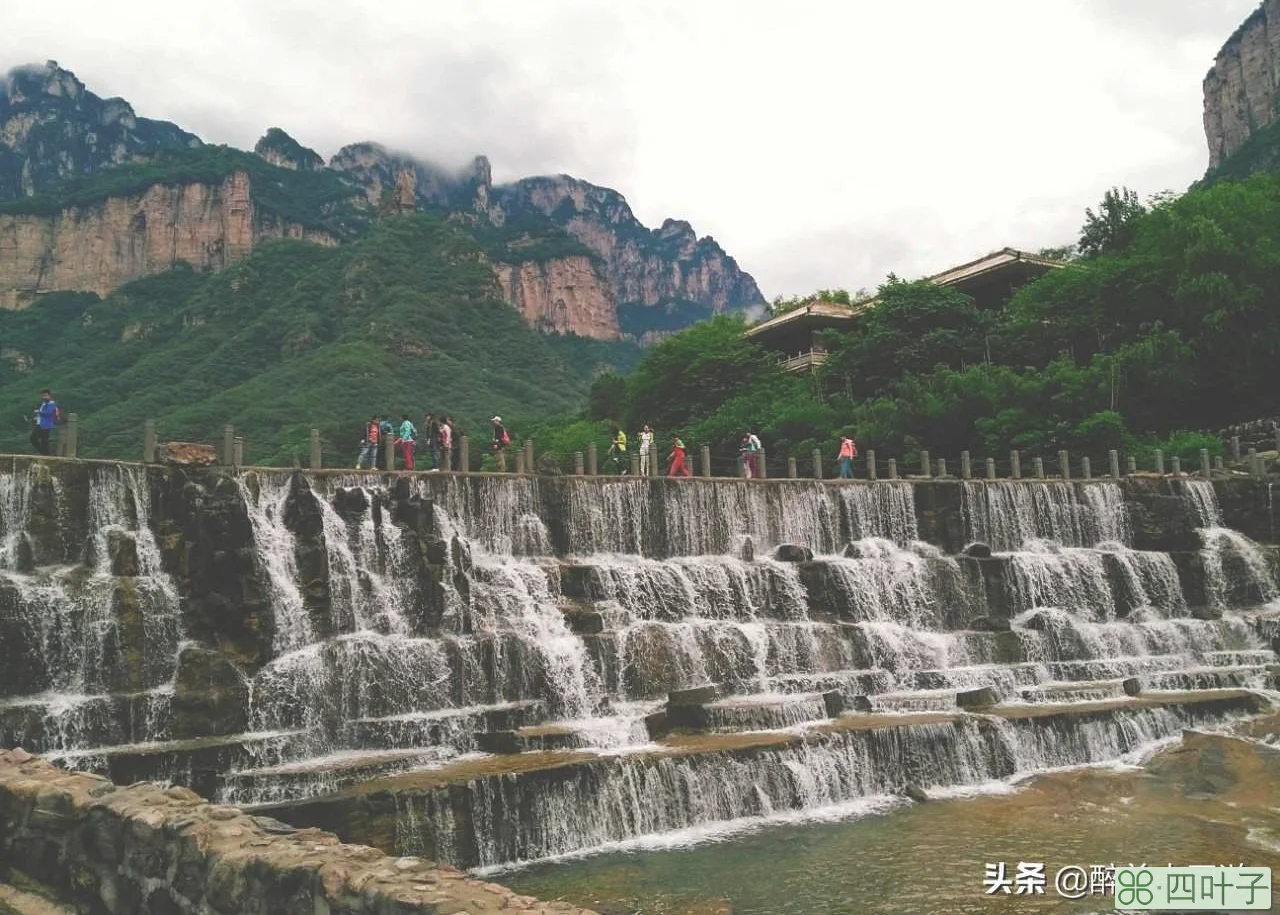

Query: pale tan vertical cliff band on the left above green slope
left=0, top=171, right=337, bottom=308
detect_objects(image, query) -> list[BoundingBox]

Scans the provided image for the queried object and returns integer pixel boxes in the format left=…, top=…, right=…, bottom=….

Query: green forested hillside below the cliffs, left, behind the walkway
left=0, top=215, right=634, bottom=463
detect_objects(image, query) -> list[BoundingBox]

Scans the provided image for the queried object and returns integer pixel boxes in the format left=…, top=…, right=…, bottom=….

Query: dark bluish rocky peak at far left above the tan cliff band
left=0, top=60, right=201, bottom=200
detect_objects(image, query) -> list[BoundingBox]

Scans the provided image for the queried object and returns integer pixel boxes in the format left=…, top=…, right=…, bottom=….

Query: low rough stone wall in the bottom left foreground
left=0, top=750, right=591, bottom=915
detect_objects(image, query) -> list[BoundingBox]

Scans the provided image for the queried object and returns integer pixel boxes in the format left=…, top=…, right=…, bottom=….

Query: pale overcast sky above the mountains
left=0, top=0, right=1257, bottom=298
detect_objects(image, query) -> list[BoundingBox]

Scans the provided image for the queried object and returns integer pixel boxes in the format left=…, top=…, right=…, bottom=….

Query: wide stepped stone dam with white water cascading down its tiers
left=0, top=458, right=1280, bottom=873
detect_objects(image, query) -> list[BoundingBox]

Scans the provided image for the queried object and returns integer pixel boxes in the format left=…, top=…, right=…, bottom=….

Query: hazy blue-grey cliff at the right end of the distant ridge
left=495, top=175, right=764, bottom=334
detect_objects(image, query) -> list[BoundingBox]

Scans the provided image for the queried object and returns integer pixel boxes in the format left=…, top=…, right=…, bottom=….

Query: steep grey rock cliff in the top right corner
left=1204, top=0, right=1280, bottom=169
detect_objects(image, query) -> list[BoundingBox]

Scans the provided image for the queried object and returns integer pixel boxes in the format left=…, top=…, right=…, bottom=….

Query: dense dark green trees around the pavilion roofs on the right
left=535, top=175, right=1280, bottom=466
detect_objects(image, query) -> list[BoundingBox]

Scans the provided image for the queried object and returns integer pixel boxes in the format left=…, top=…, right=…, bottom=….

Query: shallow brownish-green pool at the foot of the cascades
left=497, top=741, right=1280, bottom=915
